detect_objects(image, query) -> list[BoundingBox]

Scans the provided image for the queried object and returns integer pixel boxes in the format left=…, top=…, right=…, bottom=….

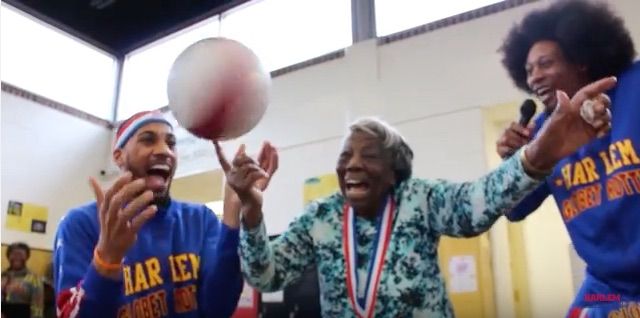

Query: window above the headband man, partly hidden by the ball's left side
left=117, top=16, right=219, bottom=120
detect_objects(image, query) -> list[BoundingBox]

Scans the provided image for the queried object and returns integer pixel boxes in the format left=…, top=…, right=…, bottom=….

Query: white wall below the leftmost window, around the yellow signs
left=0, top=92, right=110, bottom=249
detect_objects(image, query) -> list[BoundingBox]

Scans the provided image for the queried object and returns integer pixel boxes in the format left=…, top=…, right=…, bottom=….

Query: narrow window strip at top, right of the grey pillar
left=375, top=0, right=503, bottom=36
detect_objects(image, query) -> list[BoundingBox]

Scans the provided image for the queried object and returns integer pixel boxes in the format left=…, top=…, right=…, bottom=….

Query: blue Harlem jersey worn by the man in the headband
left=53, top=200, right=243, bottom=318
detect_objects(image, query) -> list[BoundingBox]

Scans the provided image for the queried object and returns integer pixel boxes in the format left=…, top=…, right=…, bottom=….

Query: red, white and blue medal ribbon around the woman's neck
left=342, top=197, right=396, bottom=318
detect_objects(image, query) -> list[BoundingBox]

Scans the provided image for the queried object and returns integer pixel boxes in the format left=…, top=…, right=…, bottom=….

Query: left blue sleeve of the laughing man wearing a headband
left=53, top=205, right=122, bottom=318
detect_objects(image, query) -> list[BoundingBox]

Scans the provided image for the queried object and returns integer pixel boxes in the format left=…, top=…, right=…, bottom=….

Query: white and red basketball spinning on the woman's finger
left=167, top=38, right=271, bottom=141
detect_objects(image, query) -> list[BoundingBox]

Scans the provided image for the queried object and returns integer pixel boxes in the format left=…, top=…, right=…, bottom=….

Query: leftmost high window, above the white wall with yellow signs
left=0, top=3, right=116, bottom=120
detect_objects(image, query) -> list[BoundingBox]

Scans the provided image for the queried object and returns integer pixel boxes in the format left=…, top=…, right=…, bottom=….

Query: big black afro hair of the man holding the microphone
left=500, top=0, right=636, bottom=92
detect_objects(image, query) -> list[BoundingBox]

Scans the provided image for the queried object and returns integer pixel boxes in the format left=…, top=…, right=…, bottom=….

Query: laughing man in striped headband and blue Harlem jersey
left=54, top=112, right=276, bottom=318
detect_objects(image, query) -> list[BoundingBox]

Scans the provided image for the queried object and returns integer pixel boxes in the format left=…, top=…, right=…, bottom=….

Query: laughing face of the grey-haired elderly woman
left=336, top=131, right=396, bottom=215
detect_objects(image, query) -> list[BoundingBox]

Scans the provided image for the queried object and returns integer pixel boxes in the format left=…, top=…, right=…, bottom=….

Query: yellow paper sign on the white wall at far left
left=5, top=201, right=49, bottom=233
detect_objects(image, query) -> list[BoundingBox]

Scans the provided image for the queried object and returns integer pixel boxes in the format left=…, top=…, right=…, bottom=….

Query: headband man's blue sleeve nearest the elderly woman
left=198, top=210, right=244, bottom=318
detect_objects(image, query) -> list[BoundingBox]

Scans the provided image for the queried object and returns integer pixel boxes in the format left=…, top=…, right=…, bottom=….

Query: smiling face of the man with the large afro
left=525, top=40, right=589, bottom=112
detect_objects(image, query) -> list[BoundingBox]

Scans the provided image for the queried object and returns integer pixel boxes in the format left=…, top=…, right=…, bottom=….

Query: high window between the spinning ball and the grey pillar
left=220, top=0, right=352, bottom=71
